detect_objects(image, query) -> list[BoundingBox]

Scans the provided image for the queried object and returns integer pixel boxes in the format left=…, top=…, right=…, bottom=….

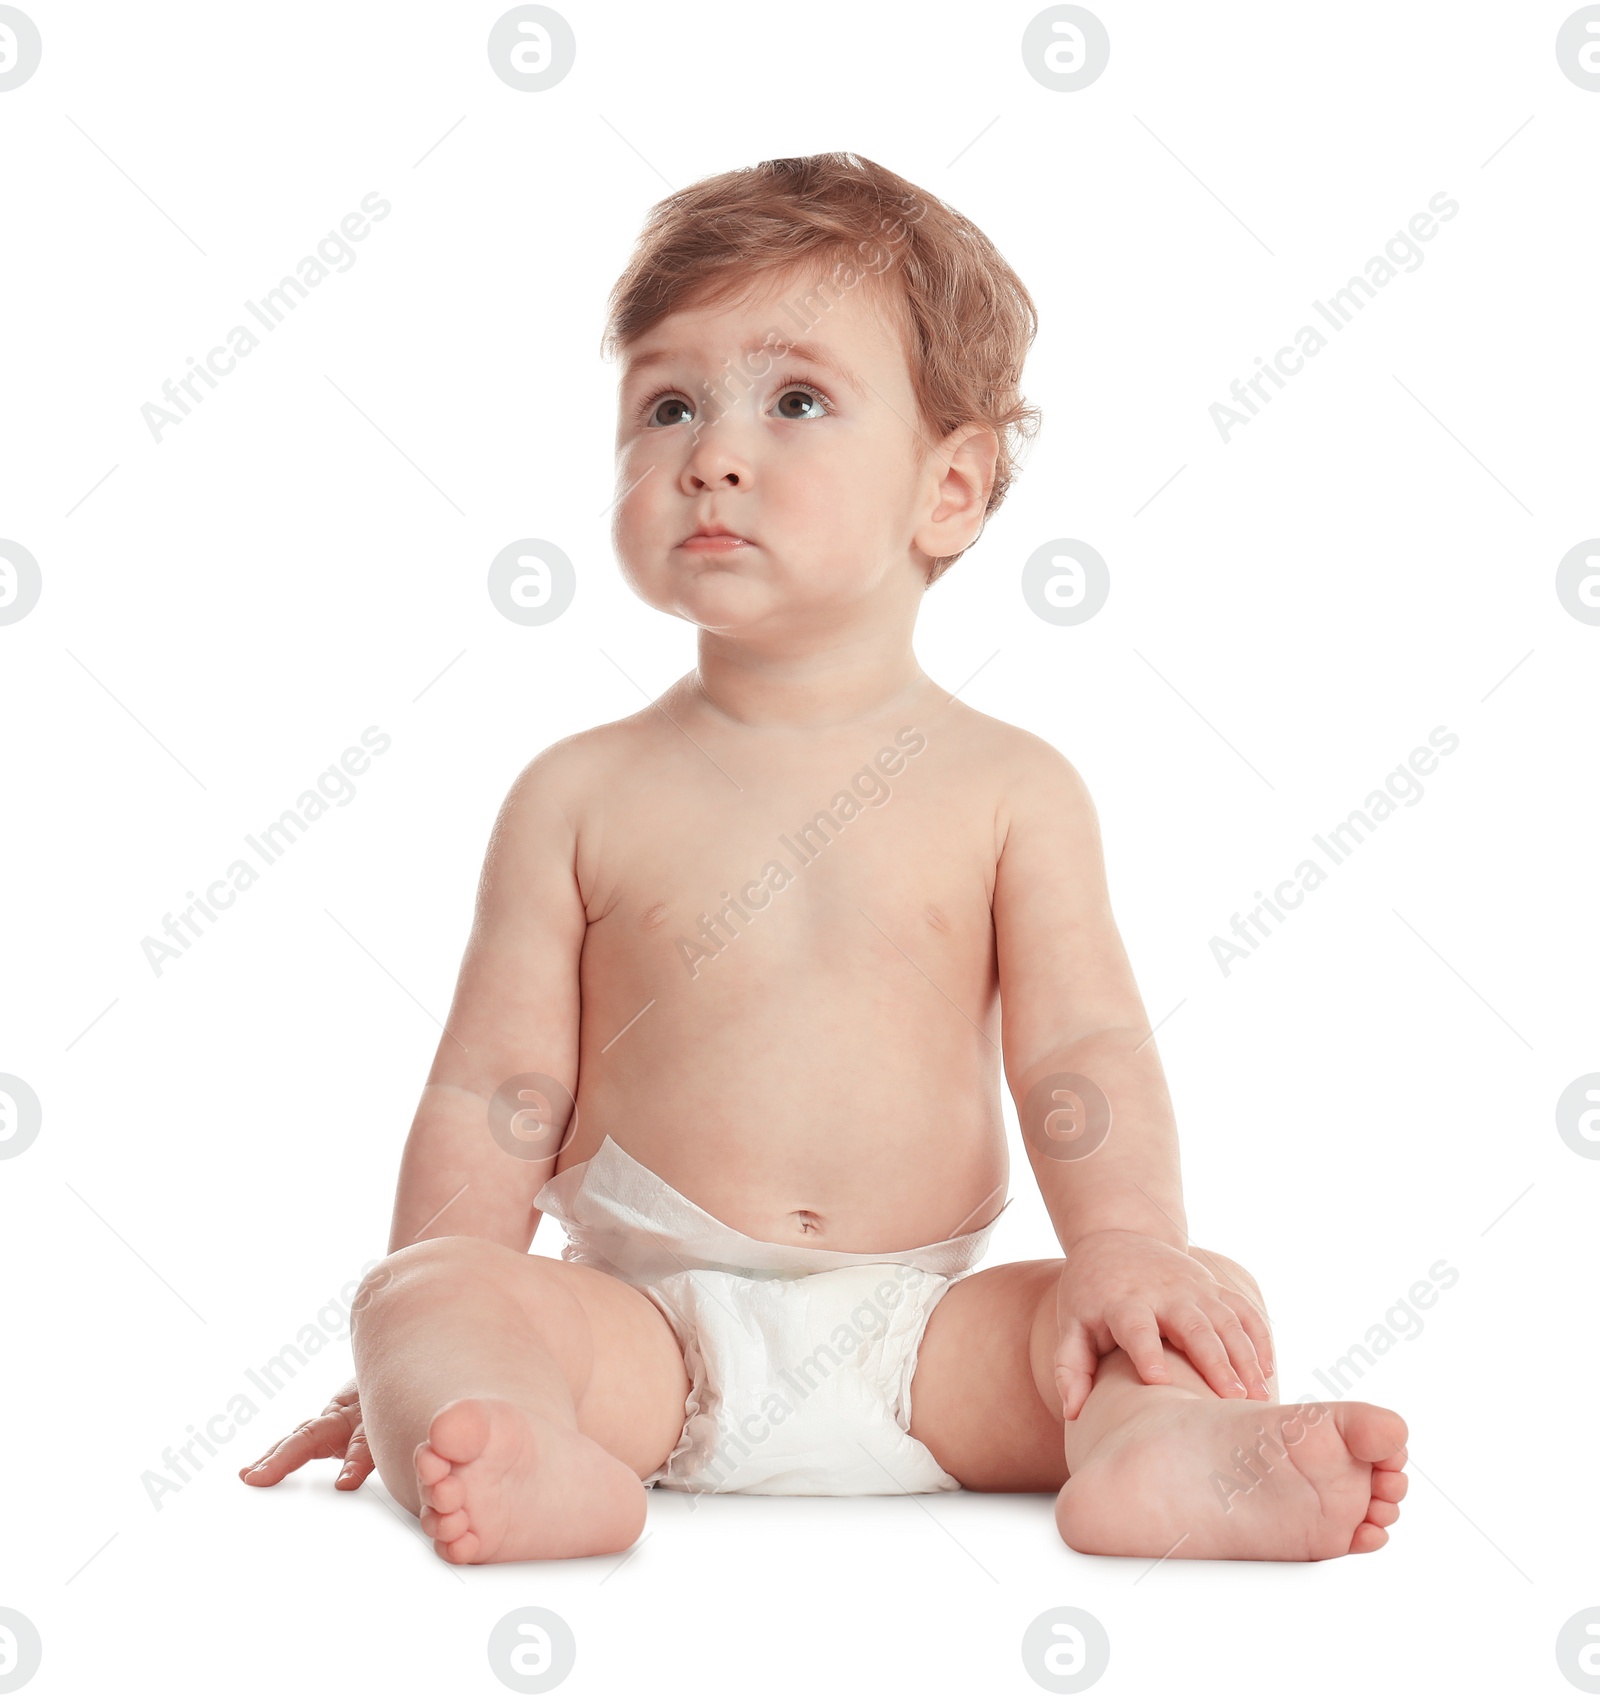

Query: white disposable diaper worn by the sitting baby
left=534, top=1135, right=1003, bottom=1493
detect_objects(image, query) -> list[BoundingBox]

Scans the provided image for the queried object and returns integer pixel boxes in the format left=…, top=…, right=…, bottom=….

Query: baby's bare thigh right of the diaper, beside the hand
left=911, top=1259, right=1066, bottom=1493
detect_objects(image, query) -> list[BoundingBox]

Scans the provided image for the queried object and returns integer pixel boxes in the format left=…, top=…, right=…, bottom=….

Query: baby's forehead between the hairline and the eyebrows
left=622, top=269, right=905, bottom=390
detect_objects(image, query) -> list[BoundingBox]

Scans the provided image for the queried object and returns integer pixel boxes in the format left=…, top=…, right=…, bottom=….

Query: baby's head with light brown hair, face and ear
left=602, top=153, right=1039, bottom=636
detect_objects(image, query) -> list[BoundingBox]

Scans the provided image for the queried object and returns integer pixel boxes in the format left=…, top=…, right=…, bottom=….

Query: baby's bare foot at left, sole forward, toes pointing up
left=417, top=1400, right=646, bottom=1565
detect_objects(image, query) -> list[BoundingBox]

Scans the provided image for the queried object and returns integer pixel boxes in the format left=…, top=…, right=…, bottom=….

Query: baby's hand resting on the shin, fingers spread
left=1056, top=1228, right=1272, bottom=1419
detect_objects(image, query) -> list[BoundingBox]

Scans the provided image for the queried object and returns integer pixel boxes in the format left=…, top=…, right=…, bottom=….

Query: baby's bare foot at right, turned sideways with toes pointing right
left=1056, top=1398, right=1406, bottom=1560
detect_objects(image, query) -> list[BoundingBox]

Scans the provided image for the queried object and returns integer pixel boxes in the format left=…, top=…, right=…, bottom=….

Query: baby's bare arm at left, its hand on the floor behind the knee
left=240, top=758, right=587, bottom=1490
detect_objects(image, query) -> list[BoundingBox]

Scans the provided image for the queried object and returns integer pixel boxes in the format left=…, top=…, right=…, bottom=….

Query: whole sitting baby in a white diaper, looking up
left=241, top=155, right=1406, bottom=1565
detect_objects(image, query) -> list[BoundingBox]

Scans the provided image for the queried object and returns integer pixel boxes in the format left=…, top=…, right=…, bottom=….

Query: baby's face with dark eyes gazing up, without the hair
left=612, top=272, right=937, bottom=638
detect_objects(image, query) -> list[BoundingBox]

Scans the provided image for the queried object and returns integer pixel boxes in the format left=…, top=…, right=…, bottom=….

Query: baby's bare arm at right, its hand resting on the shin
left=995, top=735, right=1270, bottom=1419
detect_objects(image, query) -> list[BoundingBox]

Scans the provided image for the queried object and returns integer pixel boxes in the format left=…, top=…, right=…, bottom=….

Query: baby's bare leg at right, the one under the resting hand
left=911, top=1247, right=1406, bottom=1560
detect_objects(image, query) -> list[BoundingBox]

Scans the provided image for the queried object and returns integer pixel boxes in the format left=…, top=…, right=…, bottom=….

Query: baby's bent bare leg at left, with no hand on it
left=352, top=1237, right=689, bottom=1565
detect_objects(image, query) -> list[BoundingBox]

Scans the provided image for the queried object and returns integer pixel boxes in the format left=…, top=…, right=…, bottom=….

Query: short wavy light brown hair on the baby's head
left=600, top=153, right=1039, bottom=583
